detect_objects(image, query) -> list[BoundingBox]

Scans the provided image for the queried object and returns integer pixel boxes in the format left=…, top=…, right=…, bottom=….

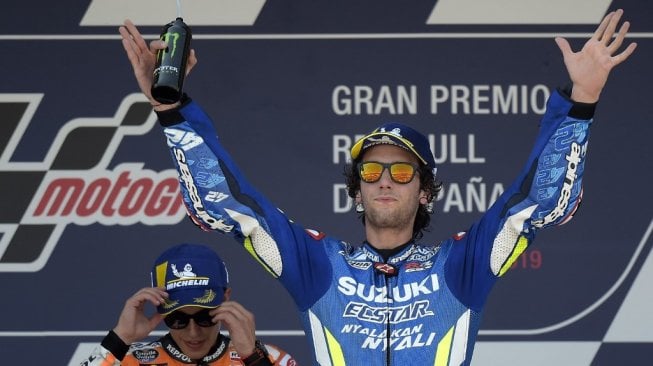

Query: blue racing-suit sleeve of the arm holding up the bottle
left=159, top=100, right=331, bottom=310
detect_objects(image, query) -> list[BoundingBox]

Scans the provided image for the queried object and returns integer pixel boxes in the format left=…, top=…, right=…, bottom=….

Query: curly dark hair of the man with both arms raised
left=343, top=157, right=442, bottom=240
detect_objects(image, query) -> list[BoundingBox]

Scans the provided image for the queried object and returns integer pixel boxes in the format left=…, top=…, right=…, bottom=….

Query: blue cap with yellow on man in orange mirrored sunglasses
left=351, top=122, right=435, bottom=169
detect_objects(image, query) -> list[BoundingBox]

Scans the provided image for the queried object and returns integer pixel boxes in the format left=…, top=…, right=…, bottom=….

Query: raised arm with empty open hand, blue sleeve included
left=445, top=10, right=636, bottom=309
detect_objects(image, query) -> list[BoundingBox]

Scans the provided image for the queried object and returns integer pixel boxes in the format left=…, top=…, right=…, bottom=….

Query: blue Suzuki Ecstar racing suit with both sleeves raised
left=159, top=90, right=594, bottom=366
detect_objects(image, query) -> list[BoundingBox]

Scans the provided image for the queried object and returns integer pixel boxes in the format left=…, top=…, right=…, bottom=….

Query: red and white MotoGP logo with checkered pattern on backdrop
left=0, top=94, right=186, bottom=272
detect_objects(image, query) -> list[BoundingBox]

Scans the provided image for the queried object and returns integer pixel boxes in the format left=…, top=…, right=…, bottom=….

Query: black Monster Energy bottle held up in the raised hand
left=152, top=17, right=192, bottom=104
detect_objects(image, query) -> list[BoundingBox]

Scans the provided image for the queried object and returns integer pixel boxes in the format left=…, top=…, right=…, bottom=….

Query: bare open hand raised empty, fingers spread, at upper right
left=555, top=9, right=637, bottom=103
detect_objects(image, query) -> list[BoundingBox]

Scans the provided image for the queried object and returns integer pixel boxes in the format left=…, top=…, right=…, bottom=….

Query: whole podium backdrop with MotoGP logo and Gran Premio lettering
left=0, top=0, right=653, bottom=366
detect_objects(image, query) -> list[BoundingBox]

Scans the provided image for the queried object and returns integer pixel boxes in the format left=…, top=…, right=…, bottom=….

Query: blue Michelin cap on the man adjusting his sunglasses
left=151, top=244, right=229, bottom=315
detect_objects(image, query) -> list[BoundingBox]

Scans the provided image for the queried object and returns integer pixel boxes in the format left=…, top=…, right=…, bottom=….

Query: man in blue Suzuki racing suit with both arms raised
left=120, top=10, right=636, bottom=366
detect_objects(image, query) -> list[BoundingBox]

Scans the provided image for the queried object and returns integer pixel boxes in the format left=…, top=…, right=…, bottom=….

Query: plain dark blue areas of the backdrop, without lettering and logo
left=0, top=0, right=653, bottom=364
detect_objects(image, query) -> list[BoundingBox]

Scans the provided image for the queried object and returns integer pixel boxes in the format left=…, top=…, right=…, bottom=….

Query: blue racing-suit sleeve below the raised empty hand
left=445, top=91, right=594, bottom=310
